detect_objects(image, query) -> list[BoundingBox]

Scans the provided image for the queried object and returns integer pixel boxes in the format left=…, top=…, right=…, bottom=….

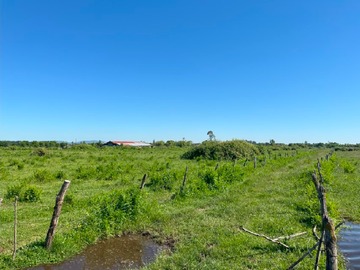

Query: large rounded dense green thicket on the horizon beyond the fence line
left=182, top=140, right=260, bottom=160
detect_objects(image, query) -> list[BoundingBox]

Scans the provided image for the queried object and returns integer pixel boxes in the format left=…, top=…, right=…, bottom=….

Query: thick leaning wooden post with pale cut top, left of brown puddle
left=45, top=180, right=70, bottom=249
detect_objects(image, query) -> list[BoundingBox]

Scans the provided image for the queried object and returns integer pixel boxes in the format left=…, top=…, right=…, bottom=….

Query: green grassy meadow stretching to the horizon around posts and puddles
left=0, top=142, right=360, bottom=269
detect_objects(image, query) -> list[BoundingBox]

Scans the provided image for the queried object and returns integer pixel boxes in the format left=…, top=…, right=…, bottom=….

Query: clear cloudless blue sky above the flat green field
left=0, top=0, right=360, bottom=143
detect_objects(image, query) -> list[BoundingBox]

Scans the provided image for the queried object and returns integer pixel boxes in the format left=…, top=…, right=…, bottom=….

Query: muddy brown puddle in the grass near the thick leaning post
left=27, top=235, right=166, bottom=270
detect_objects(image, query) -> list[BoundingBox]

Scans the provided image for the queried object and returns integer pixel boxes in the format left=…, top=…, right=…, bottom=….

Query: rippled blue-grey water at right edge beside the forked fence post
left=338, top=222, right=360, bottom=270
